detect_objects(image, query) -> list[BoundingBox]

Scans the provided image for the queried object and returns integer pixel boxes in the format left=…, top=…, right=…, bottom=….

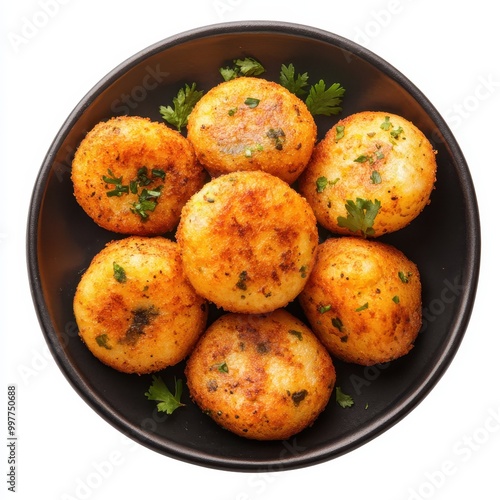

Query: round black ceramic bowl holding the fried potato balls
left=27, top=22, right=480, bottom=471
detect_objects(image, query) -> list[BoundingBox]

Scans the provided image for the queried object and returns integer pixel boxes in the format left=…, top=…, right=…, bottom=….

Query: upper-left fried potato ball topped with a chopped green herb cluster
left=71, top=116, right=206, bottom=236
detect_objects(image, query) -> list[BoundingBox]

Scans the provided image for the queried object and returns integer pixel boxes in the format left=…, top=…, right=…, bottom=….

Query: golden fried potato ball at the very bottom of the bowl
left=185, top=309, right=335, bottom=440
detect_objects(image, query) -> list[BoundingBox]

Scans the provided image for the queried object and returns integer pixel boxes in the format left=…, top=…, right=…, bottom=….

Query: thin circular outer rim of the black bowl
left=26, top=20, right=481, bottom=472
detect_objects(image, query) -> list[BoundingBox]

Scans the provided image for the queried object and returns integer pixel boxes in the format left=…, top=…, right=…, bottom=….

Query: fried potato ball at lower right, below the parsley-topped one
left=299, top=236, right=422, bottom=366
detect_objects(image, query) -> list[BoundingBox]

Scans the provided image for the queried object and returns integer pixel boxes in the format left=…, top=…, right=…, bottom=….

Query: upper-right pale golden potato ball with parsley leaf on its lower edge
left=299, top=111, right=436, bottom=237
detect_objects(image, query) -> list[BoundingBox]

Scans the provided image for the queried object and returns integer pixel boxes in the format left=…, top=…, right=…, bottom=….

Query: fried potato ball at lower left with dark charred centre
left=73, top=236, right=208, bottom=374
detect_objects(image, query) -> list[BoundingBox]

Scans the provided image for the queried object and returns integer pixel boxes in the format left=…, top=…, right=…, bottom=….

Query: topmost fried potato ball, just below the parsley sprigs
left=187, top=77, right=317, bottom=184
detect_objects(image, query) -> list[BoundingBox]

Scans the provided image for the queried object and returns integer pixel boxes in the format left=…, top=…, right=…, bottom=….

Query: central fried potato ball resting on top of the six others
left=176, top=171, right=318, bottom=313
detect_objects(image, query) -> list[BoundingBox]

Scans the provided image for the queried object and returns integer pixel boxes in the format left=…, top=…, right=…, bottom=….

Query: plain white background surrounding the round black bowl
left=0, top=0, right=500, bottom=500
